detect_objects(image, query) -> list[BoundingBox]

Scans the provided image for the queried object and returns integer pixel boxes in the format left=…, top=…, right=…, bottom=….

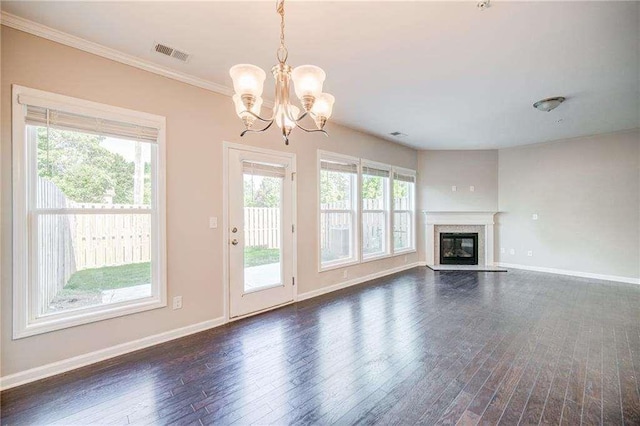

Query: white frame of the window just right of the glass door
left=316, top=150, right=361, bottom=272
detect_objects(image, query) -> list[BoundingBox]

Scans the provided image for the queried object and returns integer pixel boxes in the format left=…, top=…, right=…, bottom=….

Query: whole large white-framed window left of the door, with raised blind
left=13, top=86, right=166, bottom=338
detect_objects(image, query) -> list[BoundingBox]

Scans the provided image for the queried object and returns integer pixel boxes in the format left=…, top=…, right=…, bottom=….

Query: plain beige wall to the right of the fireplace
left=496, top=130, right=640, bottom=278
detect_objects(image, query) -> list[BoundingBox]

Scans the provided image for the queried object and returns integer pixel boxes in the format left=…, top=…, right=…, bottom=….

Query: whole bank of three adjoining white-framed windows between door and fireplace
left=319, top=151, right=416, bottom=271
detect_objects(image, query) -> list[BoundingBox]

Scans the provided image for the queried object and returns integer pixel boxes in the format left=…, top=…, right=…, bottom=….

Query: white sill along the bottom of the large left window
left=13, top=298, right=167, bottom=340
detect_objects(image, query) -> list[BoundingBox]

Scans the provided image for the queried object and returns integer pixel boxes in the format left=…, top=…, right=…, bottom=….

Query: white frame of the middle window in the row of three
left=358, top=159, right=393, bottom=263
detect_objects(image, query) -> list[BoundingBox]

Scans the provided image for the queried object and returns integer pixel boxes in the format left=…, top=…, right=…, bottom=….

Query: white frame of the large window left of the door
left=12, top=85, right=167, bottom=339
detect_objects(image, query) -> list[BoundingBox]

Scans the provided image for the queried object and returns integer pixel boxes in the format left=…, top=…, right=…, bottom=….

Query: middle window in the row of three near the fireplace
left=361, top=163, right=390, bottom=259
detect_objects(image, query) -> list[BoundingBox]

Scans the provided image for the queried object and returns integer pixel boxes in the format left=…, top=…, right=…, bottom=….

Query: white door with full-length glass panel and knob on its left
left=227, top=148, right=295, bottom=318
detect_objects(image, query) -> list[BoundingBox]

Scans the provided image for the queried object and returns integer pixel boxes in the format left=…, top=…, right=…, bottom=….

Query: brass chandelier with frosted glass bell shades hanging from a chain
left=229, top=0, right=335, bottom=145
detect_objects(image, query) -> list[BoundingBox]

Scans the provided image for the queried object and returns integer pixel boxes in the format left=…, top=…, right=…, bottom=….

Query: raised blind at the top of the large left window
left=25, top=105, right=158, bottom=143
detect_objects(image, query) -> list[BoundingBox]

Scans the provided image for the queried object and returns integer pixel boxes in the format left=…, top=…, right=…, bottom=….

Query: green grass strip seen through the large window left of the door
left=64, top=262, right=151, bottom=292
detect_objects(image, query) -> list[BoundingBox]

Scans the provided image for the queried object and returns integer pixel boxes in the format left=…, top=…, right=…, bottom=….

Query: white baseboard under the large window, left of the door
left=0, top=317, right=225, bottom=390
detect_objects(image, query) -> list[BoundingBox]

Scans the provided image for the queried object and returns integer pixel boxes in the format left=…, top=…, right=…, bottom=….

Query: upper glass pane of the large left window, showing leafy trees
left=35, top=126, right=153, bottom=209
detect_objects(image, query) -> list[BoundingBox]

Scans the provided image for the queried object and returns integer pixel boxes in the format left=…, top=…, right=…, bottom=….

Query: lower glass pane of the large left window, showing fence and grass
left=36, top=214, right=152, bottom=317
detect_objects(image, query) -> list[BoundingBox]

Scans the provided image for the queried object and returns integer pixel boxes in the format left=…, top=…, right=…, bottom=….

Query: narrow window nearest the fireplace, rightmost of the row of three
left=393, top=170, right=416, bottom=253
